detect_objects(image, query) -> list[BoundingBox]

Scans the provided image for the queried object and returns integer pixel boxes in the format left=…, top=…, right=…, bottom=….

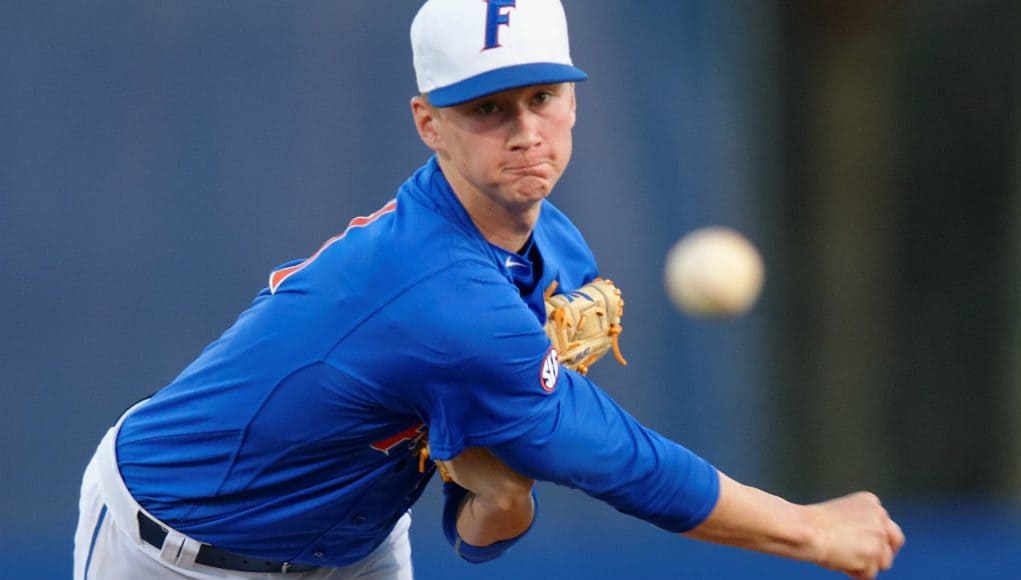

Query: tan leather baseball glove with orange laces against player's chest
left=545, top=278, right=628, bottom=375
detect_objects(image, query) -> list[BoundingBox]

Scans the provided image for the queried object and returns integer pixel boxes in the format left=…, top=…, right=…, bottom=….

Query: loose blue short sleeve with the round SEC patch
left=414, top=265, right=561, bottom=460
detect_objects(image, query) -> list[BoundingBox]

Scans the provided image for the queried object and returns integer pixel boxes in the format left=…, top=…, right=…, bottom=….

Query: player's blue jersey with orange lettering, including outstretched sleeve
left=117, top=158, right=718, bottom=566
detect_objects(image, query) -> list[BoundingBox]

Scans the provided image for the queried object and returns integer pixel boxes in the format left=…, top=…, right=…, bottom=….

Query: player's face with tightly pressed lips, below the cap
left=412, top=83, right=576, bottom=211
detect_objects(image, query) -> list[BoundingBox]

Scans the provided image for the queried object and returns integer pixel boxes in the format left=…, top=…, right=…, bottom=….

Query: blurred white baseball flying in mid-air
left=665, top=227, right=765, bottom=316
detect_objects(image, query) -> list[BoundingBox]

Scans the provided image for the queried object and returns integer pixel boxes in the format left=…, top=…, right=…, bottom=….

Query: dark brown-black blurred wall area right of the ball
left=776, top=1, right=1021, bottom=495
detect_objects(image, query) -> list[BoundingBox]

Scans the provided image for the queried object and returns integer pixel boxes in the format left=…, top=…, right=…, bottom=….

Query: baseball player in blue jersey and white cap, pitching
left=75, top=0, right=904, bottom=580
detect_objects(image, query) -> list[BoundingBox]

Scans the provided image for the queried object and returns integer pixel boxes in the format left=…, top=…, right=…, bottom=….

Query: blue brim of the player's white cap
left=429, top=62, right=588, bottom=107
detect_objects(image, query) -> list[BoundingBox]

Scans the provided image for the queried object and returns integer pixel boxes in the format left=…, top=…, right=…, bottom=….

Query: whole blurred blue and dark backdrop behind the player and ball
left=0, top=0, right=1021, bottom=580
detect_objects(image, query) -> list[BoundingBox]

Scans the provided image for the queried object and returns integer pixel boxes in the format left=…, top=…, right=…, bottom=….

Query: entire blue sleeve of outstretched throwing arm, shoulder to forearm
left=383, top=259, right=719, bottom=532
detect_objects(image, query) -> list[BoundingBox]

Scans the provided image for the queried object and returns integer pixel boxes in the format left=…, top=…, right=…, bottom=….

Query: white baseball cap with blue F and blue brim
left=411, top=0, right=588, bottom=107
